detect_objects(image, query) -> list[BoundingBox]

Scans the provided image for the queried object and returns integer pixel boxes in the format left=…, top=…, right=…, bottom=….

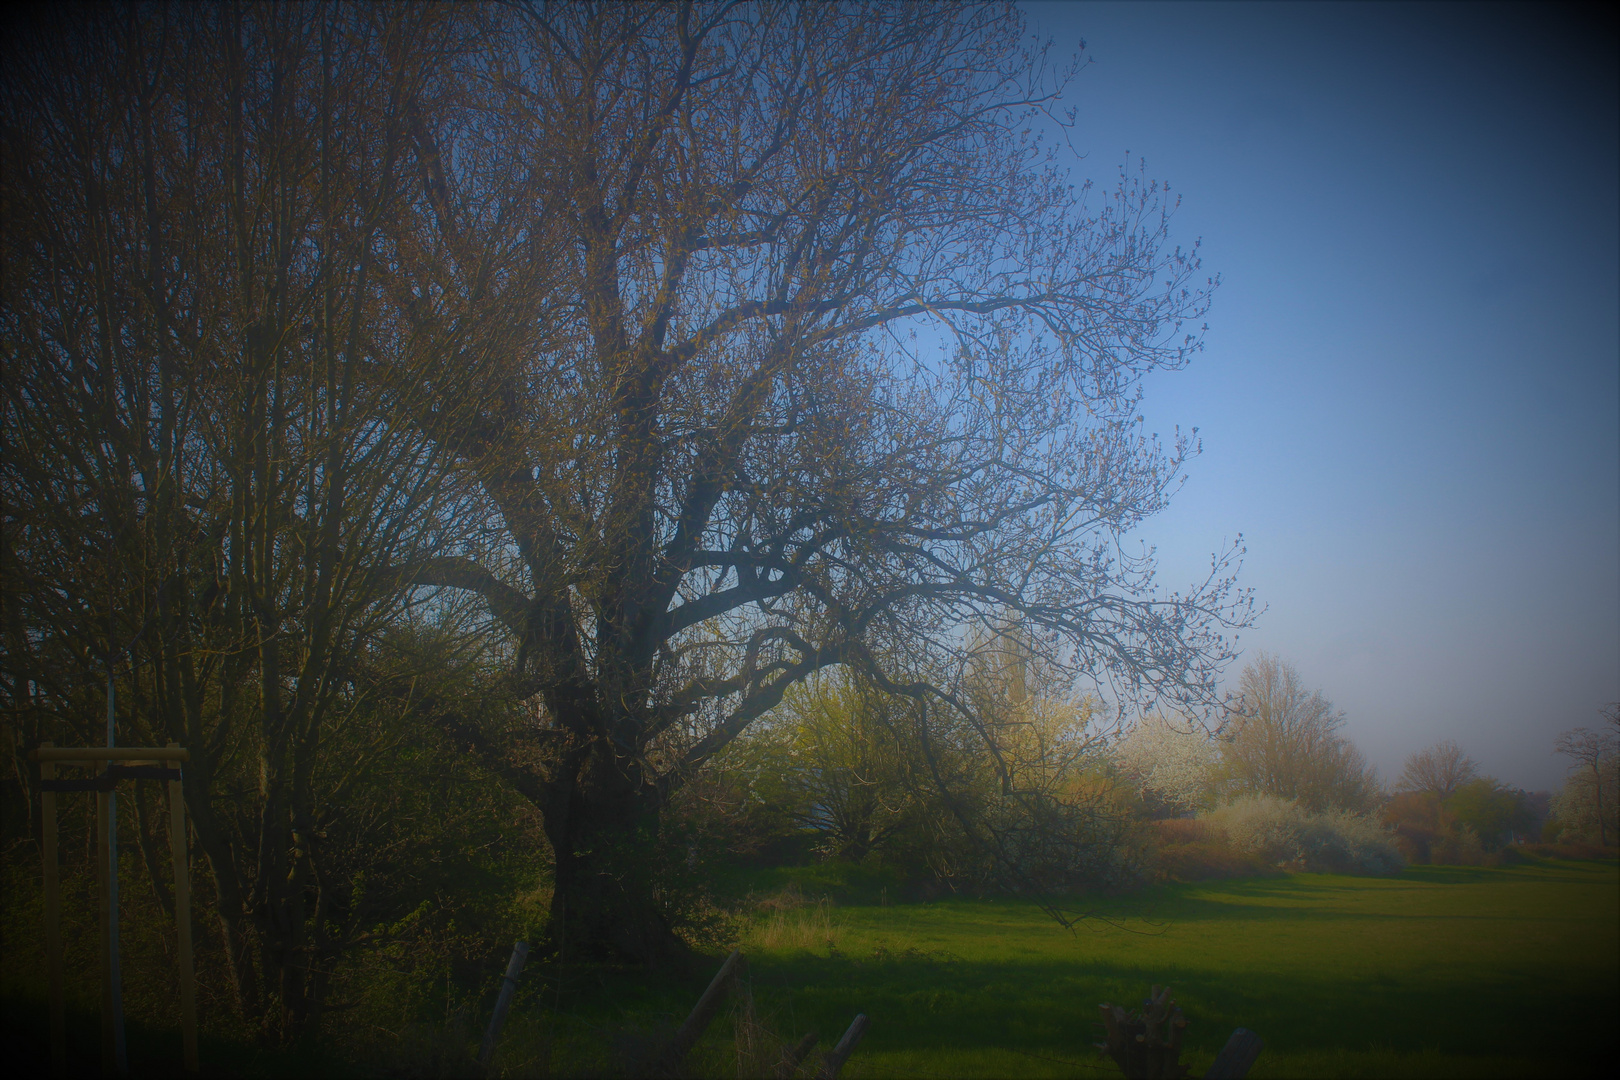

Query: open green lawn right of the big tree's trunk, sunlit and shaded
left=641, top=863, right=1620, bottom=1077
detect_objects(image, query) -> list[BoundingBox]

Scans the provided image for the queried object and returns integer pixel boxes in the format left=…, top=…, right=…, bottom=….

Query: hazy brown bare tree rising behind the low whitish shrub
left=1225, top=653, right=1377, bottom=810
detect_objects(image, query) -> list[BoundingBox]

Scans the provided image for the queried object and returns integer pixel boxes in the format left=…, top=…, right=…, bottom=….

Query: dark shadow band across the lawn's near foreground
left=741, top=957, right=1620, bottom=1061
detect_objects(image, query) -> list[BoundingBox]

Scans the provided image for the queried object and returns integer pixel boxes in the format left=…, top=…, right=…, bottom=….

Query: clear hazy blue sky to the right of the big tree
left=1024, top=3, right=1620, bottom=789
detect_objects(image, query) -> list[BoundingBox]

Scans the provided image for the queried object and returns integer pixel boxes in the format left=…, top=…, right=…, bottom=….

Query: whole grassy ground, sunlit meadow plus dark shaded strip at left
left=6, top=863, right=1620, bottom=1080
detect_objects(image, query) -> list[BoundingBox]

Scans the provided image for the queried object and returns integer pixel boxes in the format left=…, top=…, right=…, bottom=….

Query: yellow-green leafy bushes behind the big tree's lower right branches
left=711, top=667, right=1134, bottom=887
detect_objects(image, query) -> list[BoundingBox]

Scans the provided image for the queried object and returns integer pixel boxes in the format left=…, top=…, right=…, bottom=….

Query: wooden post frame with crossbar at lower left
left=29, top=742, right=198, bottom=1074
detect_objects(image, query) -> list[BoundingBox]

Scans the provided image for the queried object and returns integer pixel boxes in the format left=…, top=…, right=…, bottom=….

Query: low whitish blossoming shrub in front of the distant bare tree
left=1205, top=795, right=1406, bottom=874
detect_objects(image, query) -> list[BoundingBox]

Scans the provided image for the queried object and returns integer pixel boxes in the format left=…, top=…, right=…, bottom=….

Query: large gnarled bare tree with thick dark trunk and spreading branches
left=397, top=3, right=1249, bottom=960
